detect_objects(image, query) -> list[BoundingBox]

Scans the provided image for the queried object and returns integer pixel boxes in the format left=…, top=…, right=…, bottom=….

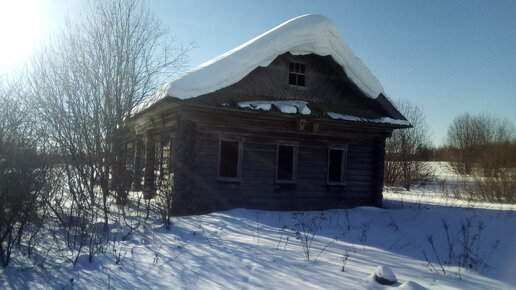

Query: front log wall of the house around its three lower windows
left=171, top=120, right=383, bottom=214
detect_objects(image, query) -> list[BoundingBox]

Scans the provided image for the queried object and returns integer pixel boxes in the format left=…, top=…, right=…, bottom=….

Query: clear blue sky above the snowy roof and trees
left=0, top=0, right=516, bottom=145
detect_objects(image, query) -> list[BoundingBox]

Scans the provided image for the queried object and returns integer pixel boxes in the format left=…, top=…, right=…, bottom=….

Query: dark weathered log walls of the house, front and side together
left=128, top=98, right=393, bottom=215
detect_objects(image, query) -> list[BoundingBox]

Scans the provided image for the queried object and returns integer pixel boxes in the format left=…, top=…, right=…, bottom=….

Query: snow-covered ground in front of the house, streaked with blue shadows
left=0, top=163, right=516, bottom=289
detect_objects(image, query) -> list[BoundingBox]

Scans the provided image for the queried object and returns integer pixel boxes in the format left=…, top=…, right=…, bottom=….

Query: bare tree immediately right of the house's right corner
left=384, top=101, right=433, bottom=190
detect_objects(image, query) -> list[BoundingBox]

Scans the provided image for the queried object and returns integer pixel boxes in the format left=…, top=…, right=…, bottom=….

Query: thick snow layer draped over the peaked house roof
left=133, top=14, right=383, bottom=113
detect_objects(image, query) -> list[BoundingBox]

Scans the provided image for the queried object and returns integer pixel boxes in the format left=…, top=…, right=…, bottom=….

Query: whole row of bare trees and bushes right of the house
left=384, top=109, right=516, bottom=203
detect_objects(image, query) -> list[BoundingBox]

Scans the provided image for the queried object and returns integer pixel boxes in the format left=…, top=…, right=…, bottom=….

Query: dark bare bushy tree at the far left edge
left=0, top=80, right=50, bottom=267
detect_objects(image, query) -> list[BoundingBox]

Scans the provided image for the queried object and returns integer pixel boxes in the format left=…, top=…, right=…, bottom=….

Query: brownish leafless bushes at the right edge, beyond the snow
left=448, top=113, right=516, bottom=203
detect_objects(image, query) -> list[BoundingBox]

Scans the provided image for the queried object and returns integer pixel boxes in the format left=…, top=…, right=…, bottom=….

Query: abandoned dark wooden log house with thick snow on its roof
left=128, top=15, right=410, bottom=215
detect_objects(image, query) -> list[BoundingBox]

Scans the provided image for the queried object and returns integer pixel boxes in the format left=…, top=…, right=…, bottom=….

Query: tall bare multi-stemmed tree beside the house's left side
left=29, top=0, right=188, bottom=247
